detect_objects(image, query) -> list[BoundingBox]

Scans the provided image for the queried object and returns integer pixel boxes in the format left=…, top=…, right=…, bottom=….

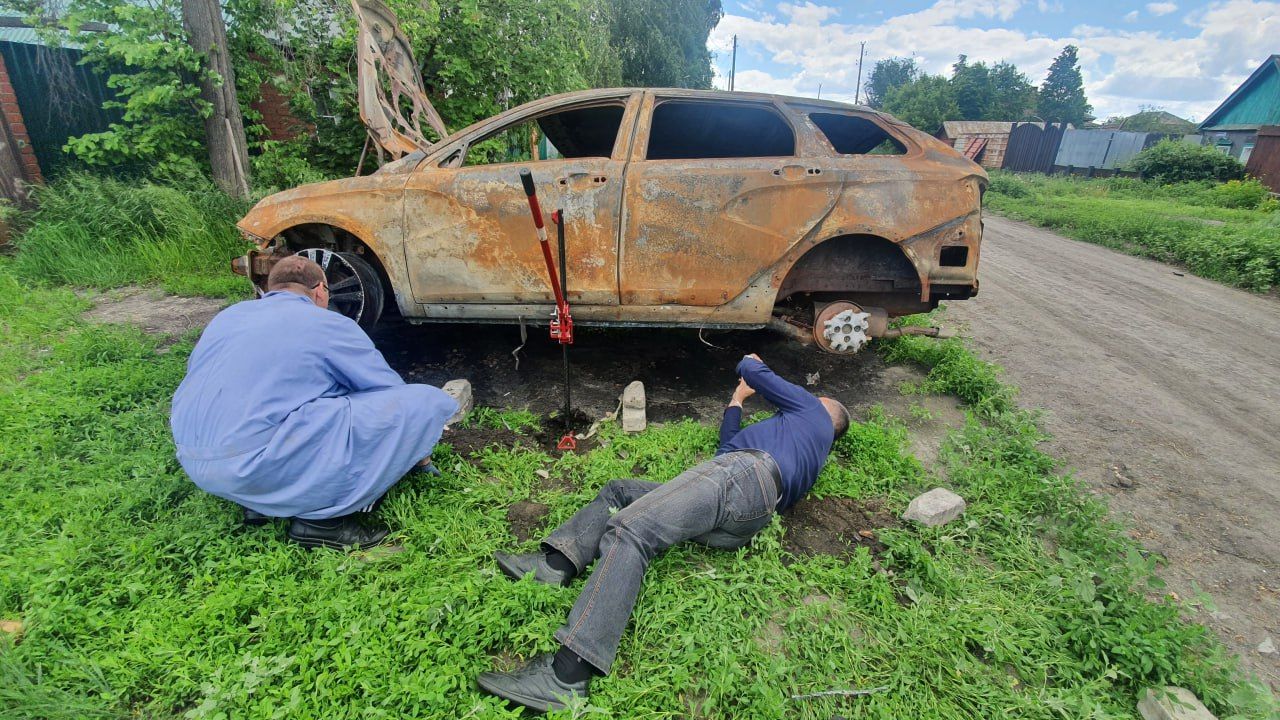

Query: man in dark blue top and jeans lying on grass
left=479, top=355, right=849, bottom=711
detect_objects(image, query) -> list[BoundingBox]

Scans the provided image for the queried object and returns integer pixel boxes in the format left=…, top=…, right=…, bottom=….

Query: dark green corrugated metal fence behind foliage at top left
left=0, top=42, right=122, bottom=177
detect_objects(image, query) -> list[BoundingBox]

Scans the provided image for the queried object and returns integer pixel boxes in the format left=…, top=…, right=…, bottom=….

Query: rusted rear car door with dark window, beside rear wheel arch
left=618, top=94, right=840, bottom=306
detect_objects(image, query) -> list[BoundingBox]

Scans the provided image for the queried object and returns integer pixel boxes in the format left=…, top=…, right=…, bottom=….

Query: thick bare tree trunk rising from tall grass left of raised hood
left=182, top=0, right=248, bottom=197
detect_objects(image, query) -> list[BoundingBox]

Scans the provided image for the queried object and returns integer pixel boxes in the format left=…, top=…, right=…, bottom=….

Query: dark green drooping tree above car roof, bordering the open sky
left=609, top=0, right=724, bottom=87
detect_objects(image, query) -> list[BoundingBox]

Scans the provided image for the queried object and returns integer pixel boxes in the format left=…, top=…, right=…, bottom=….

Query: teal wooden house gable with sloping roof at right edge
left=1199, top=55, right=1280, bottom=164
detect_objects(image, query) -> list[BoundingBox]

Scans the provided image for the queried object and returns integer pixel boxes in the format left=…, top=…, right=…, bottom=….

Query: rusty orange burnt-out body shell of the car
left=232, top=0, right=987, bottom=327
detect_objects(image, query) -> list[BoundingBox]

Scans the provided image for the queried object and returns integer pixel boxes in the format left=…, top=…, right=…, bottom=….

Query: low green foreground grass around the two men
left=0, top=260, right=1276, bottom=720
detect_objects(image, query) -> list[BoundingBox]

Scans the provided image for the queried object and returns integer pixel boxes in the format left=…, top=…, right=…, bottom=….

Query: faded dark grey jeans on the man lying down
left=543, top=451, right=778, bottom=674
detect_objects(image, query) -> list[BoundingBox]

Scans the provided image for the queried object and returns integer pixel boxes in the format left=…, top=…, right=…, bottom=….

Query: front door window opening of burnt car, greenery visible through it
left=463, top=105, right=625, bottom=167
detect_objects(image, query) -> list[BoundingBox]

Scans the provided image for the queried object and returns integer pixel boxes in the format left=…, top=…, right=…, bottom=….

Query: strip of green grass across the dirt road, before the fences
left=986, top=172, right=1280, bottom=292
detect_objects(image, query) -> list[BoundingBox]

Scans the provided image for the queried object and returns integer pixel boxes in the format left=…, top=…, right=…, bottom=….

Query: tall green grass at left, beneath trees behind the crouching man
left=14, top=173, right=248, bottom=297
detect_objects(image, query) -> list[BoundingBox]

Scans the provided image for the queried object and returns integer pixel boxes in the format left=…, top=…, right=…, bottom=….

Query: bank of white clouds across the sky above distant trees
left=708, top=0, right=1280, bottom=118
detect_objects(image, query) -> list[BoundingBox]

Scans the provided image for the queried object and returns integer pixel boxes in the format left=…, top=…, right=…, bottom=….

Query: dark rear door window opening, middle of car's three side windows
left=646, top=100, right=795, bottom=160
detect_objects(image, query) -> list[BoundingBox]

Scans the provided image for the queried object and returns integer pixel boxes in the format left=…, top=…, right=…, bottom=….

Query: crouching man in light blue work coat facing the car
left=170, top=255, right=457, bottom=547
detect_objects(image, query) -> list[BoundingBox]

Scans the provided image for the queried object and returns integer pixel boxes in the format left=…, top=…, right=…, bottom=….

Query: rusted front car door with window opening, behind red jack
left=404, top=92, right=640, bottom=305
